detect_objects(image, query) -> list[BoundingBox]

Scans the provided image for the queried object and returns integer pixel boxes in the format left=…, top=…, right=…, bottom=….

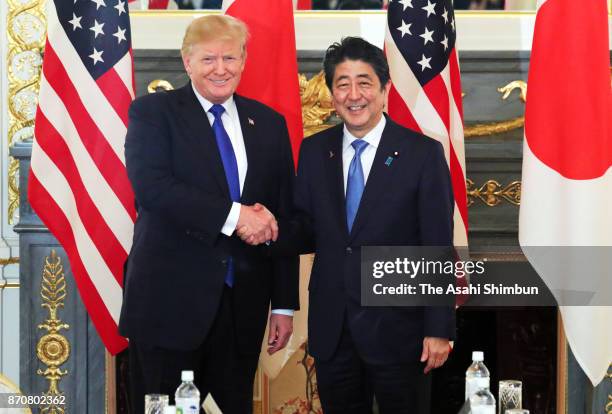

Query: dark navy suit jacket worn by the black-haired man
left=286, top=118, right=455, bottom=363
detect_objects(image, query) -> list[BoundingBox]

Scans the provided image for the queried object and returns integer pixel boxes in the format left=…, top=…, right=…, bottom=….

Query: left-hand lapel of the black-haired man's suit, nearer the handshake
left=323, top=126, right=348, bottom=235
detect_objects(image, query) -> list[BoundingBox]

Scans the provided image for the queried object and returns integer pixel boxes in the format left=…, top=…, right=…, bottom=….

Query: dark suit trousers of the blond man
left=129, top=287, right=259, bottom=414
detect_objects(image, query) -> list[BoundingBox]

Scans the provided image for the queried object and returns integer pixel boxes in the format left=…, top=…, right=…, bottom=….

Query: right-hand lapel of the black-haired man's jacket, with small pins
left=350, top=118, right=401, bottom=240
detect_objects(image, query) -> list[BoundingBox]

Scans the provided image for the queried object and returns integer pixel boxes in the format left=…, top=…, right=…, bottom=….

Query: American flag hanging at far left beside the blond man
left=28, top=0, right=136, bottom=354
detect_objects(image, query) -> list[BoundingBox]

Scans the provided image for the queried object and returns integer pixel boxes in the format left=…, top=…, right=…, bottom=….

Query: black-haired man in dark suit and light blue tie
left=256, top=37, right=455, bottom=414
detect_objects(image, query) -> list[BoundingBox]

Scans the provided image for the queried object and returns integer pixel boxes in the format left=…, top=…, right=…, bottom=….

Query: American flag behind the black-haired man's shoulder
left=385, top=0, right=468, bottom=246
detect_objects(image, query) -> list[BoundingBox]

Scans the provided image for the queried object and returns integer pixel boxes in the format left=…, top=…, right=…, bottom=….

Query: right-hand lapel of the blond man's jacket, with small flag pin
left=234, top=94, right=261, bottom=204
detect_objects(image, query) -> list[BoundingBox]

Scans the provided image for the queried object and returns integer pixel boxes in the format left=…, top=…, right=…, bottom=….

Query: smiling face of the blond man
left=183, top=39, right=246, bottom=104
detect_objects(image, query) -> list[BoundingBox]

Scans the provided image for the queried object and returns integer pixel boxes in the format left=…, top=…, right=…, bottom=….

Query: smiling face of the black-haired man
left=332, top=60, right=391, bottom=138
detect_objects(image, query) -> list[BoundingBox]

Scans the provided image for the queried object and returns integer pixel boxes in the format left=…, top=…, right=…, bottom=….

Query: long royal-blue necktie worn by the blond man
left=208, top=104, right=240, bottom=287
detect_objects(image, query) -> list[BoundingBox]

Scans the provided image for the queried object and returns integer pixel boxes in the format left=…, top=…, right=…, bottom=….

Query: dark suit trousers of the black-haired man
left=315, top=320, right=431, bottom=414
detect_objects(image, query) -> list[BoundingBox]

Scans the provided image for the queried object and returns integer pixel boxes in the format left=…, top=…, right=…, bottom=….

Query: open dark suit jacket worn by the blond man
left=119, top=84, right=299, bottom=353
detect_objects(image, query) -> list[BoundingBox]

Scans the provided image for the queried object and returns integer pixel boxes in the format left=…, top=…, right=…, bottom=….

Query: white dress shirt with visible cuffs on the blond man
left=191, top=84, right=293, bottom=316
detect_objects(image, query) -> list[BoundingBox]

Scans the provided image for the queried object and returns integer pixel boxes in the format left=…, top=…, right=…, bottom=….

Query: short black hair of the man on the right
left=323, top=37, right=391, bottom=91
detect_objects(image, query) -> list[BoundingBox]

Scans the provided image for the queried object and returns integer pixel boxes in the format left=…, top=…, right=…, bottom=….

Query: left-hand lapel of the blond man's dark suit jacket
left=178, top=83, right=229, bottom=197
